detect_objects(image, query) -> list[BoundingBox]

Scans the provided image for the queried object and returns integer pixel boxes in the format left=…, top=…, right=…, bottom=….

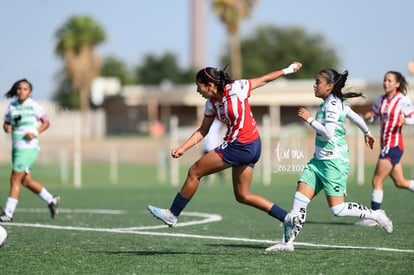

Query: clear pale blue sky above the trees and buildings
left=0, top=0, right=414, bottom=100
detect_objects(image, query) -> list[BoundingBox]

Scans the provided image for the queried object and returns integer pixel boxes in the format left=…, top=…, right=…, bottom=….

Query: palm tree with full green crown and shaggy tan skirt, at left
left=55, top=16, right=106, bottom=112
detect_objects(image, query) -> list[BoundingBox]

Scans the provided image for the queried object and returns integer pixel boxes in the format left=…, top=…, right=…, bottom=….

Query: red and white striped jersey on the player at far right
left=372, top=92, right=414, bottom=150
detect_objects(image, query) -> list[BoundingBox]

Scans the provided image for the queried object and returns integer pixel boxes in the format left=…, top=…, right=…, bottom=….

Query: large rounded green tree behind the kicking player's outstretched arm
left=221, top=26, right=340, bottom=78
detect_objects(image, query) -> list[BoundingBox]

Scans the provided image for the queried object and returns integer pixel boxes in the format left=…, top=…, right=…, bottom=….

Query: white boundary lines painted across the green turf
left=4, top=209, right=414, bottom=253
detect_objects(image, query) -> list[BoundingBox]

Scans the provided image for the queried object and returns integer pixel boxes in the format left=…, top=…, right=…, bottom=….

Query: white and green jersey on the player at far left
left=4, top=98, right=47, bottom=150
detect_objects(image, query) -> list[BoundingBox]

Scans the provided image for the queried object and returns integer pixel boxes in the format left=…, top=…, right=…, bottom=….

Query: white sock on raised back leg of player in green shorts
left=330, top=202, right=378, bottom=220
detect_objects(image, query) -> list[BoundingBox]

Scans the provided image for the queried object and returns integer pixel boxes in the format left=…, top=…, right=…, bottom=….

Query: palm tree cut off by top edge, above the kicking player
left=213, top=0, right=256, bottom=79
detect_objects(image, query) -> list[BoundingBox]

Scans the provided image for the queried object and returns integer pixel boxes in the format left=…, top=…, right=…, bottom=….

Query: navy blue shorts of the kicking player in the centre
left=214, top=137, right=262, bottom=168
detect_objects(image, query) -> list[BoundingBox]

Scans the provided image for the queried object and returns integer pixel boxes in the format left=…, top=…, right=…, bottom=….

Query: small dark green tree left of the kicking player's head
left=135, top=53, right=195, bottom=85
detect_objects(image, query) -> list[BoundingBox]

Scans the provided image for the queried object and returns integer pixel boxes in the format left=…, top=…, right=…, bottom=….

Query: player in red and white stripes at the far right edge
left=357, top=71, right=414, bottom=229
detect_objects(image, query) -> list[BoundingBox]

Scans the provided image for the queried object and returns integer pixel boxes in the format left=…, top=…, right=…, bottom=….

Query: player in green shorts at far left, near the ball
left=0, top=79, right=60, bottom=222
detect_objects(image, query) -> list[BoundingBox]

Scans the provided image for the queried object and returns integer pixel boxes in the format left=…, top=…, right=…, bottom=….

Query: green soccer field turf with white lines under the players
left=0, top=165, right=414, bottom=274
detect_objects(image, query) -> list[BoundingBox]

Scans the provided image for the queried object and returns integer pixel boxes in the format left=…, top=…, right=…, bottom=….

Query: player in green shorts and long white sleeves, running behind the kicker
left=266, top=69, right=393, bottom=251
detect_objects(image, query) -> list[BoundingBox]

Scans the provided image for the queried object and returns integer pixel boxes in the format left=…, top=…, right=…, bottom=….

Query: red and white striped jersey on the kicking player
left=204, top=79, right=259, bottom=143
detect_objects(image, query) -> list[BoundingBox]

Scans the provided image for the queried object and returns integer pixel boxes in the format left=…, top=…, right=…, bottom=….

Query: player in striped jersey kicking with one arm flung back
left=148, top=62, right=302, bottom=237
